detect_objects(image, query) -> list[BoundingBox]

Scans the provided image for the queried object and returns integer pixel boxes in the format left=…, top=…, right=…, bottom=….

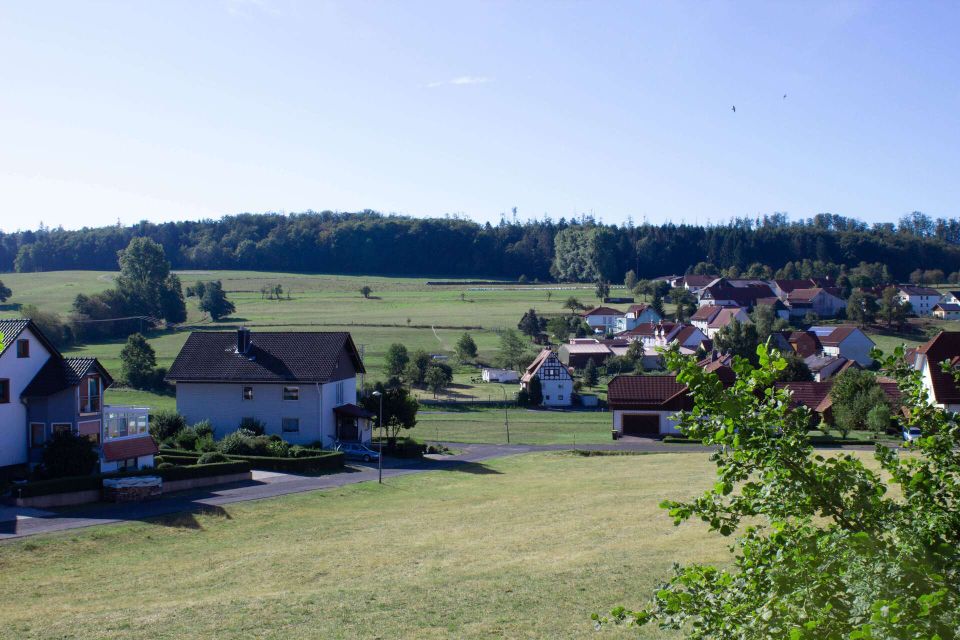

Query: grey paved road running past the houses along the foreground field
left=0, top=438, right=868, bottom=541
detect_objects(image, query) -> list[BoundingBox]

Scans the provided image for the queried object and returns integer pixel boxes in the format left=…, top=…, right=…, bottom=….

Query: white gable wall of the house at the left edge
left=0, top=329, right=50, bottom=467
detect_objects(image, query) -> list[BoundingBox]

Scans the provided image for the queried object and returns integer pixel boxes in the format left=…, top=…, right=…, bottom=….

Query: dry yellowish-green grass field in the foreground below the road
left=0, top=453, right=728, bottom=640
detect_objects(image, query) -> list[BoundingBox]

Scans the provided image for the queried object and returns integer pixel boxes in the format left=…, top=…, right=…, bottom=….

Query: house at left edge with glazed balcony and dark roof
left=0, top=319, right=157, bottom=472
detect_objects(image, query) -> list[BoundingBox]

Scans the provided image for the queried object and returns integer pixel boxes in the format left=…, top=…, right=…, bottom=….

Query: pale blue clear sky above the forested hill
left=0, top=0, right=960, bottom=230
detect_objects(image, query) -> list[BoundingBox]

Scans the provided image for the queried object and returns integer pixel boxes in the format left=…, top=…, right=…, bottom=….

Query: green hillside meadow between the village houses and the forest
left=0, top=271, right=652, bottom=408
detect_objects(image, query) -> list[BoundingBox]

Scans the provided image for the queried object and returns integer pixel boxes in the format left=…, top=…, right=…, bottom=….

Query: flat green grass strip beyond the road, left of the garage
left=410, top=405, right=613, bottom=444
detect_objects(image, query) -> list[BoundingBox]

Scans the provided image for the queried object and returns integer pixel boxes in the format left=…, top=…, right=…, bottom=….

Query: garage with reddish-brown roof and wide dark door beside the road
left=607, top=375, right=693, bottom=438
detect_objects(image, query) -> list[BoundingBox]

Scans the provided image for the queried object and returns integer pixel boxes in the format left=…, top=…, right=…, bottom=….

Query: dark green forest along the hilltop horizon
left=0, top=211, right=960, bottom=282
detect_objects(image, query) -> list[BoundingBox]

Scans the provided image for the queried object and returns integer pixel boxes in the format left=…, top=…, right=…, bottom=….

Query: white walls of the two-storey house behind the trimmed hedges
left=177, top=378, right=357, bottom=446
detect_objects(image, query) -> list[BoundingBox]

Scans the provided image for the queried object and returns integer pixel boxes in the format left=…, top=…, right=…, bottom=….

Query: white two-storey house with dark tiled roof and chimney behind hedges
left=167, top=328, right=374, bottom=447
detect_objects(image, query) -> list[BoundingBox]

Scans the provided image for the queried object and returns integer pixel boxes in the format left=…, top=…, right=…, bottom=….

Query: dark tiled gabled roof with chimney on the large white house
left=167, top=331, right=366, bottom=383
